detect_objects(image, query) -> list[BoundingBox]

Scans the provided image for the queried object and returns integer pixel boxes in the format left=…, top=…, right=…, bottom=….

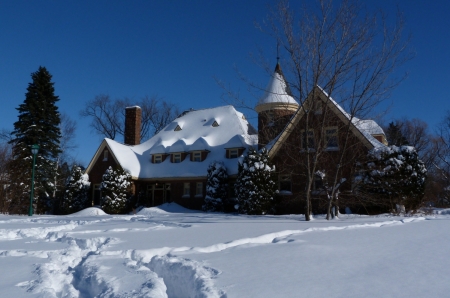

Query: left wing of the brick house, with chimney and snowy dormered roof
left=86, top=106, right=257, bottom=209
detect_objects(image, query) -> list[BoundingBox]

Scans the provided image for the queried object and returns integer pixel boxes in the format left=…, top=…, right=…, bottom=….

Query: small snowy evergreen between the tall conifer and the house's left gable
left=62, top=165, right=91, bottom=214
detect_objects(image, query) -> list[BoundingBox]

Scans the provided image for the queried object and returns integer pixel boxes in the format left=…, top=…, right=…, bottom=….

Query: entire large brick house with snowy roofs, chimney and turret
left=86, top=64, right=387, bottom=213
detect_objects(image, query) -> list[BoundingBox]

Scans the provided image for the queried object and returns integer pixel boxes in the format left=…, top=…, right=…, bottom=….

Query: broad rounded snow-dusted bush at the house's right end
left=359, top=146, right=427, bottom=211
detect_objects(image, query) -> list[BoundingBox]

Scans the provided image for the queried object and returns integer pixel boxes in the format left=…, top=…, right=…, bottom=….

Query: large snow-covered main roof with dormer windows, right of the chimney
left=105, top=106, right=258, bottom=179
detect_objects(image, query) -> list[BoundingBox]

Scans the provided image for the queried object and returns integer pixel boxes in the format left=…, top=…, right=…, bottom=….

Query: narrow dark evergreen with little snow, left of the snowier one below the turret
left=202, top=161, right=228, bottom=212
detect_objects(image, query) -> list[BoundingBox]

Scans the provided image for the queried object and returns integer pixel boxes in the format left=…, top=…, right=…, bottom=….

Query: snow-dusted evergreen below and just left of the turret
left=234, top=148, right=278, bottom=214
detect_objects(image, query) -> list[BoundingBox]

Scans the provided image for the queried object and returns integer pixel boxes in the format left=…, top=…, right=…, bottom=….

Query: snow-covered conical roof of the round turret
left=257, top=64, right=298, bottom=106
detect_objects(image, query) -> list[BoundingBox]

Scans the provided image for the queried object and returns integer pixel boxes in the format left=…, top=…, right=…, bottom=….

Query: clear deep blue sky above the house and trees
left=0, top=0, right=450, bottom=166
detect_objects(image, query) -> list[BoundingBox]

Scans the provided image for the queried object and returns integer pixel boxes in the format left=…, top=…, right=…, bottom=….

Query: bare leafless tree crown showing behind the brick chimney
left=80, top=94, right=180, bottom=141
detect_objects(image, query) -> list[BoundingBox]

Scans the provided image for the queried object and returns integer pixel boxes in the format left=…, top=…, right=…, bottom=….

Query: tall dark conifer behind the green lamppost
left=9, top=67, right=61, bottom=213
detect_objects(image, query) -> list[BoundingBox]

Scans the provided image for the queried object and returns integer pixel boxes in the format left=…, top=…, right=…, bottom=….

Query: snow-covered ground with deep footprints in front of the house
left=0, top=204, right=450, bottom=298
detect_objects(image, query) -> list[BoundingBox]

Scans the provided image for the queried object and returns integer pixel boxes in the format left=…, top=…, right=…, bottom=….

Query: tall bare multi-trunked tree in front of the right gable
left=260, top=0, right=412, bottom=220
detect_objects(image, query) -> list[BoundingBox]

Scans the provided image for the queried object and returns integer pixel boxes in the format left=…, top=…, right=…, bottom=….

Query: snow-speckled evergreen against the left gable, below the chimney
left=101, top=167, right=131, bottom=214
